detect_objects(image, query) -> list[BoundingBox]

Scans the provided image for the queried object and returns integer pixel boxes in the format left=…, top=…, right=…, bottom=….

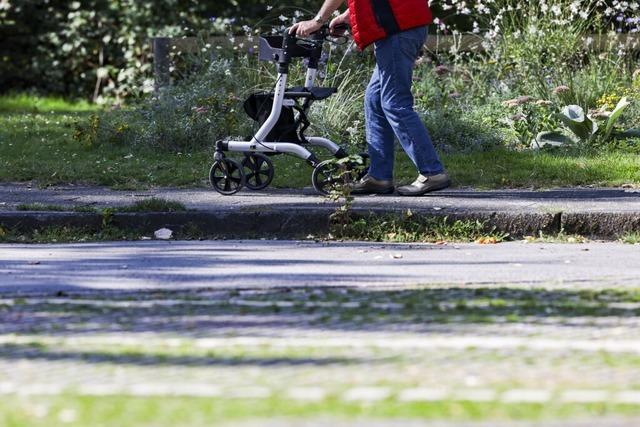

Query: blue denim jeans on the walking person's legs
left=365, top=27, right=444, bottom=180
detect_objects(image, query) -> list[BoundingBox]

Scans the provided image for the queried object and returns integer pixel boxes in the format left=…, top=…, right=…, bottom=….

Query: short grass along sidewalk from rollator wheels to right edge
left=273, top=149, right=640, bottom=189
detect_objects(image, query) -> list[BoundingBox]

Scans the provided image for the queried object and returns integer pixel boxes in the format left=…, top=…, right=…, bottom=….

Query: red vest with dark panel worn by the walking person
left=348, top=0, right=433, bottom=49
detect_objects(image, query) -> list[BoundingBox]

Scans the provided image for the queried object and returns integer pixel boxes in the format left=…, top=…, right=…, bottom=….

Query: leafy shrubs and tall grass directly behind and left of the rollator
left=86, top=41, right=370, bottom=152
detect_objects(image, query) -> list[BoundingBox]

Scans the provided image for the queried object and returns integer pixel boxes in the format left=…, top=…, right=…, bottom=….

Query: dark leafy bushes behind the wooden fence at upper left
left=0, top=0, right=310, bottom=100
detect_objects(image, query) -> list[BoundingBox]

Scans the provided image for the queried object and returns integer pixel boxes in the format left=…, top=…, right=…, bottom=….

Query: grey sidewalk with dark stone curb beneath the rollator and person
left=0, top=183, right=640, bottom=238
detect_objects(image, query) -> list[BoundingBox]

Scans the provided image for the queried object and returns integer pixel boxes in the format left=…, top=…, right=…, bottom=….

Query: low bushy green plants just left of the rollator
left=79, top=60, right=251, bottom=153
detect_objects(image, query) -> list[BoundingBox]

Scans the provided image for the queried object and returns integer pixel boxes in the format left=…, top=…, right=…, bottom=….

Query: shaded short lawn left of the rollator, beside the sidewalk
left=0, top=113, right=212, bottom=189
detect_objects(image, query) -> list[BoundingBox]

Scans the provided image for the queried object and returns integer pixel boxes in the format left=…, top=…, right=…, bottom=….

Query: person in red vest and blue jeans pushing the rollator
left=289, top=0, right=451, bottom=196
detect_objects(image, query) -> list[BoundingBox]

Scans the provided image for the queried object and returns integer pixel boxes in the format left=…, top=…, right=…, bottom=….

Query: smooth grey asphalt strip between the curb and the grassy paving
left=0, top=241, right=640, bottom=292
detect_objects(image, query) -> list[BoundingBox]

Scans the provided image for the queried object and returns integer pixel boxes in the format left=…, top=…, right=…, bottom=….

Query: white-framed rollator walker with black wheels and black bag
left=209, top=25, right=363, bottom=195
